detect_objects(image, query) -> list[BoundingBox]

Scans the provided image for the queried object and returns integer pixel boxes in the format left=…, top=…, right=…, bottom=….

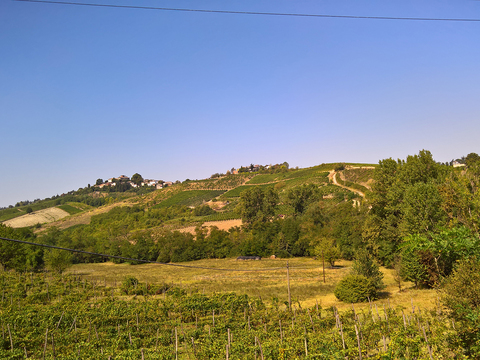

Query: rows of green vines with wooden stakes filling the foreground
left=0, top=272, right=461, bottom=359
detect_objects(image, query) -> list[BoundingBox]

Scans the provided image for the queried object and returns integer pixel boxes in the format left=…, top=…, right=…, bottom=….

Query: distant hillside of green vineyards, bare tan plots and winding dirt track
left=0, top=164, right=374, bottom=232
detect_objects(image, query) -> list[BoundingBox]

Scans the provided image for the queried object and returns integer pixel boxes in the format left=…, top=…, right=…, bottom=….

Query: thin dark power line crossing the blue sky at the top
left=15, top=0, right=480, bottom=22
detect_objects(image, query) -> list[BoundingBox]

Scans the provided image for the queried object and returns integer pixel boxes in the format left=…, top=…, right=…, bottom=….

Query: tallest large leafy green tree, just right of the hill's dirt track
left=363, top=150, right=449, bottom=265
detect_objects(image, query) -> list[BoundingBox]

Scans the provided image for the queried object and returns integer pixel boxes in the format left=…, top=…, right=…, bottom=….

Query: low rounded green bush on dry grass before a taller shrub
left=334, top=274, right=377, bottom=303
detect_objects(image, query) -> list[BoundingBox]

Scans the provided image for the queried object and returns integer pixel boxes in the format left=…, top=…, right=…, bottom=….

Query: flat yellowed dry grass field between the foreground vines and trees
left=68, top=258, right=437, bottom=310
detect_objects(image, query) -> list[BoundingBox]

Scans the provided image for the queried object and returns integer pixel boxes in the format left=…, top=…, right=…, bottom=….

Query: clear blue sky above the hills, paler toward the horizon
left=0, top=0, right=480, bottom=206
